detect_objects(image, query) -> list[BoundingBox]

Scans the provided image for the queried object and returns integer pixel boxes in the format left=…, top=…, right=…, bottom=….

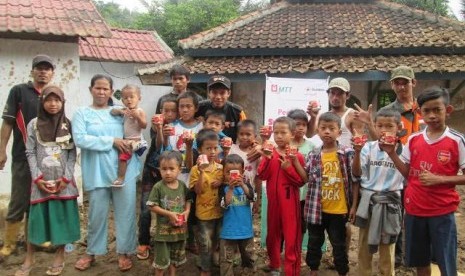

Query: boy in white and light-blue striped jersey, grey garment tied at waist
left=352, top=109, right=404, bottom=276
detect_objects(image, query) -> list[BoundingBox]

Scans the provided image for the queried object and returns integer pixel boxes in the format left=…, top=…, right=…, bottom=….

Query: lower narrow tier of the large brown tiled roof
left=139, top=55, right=465, bottom=75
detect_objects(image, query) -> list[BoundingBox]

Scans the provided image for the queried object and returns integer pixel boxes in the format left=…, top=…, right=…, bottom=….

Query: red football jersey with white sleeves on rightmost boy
left=402, top=128, right=465, bottom=217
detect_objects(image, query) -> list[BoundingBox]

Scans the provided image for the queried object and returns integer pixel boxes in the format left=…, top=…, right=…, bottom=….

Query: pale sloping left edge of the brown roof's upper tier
left=178, top=1, right=290, bottom=49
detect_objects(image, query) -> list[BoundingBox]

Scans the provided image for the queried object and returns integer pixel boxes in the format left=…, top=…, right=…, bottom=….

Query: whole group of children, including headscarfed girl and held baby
left=15, top=68, right=465, bottom=275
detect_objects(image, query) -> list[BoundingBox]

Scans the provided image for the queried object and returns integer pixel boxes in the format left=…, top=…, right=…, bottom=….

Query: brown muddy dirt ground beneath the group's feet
left=0, top=187, right=465, bottom=276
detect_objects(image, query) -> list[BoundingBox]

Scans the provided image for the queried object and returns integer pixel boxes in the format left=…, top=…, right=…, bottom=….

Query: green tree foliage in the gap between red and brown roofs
left=94, top=0, right=269, bottom=54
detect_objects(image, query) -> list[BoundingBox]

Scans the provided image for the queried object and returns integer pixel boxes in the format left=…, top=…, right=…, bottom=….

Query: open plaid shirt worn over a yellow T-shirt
left=304, top=144, right=357, bottom=224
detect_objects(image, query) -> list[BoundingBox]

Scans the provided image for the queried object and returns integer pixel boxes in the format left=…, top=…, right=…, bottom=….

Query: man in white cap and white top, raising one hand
left=307, top=78, right=364, bottom=147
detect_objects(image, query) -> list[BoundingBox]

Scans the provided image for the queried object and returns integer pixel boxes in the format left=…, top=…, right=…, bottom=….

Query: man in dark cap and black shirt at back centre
left=196, top=75, right=246, bottom=142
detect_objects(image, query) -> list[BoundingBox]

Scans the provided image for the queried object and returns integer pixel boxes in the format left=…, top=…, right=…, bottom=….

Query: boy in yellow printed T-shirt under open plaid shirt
left=304, top=112, right=358, bottom=275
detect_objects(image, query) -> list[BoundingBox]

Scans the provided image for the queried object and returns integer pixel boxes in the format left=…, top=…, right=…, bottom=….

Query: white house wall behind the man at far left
left=0, top=38, right=80, bottom=194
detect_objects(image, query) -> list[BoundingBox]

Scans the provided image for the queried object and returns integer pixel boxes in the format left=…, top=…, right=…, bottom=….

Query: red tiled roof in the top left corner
left=0, top=0, right=111, bottom=37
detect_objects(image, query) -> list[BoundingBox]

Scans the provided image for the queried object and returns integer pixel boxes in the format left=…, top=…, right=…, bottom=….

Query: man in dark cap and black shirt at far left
left=0, top=55, right=55, bottom=257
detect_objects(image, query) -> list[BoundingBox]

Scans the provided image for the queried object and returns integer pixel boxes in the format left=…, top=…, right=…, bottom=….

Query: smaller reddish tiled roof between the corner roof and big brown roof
left=79, top=28, right=173, bottom=63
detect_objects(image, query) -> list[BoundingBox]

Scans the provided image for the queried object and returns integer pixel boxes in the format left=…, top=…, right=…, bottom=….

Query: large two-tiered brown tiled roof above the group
left=139, top=0, right=465, bottom=82
